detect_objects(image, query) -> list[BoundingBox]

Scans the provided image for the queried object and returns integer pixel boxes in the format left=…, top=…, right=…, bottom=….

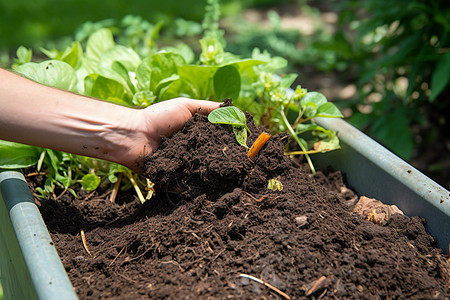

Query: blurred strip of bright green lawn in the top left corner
left=0, top=0, right=205, bottom=49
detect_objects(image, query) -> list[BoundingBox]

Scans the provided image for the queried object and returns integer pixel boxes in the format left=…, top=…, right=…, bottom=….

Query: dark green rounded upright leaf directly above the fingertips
left=213, top=65, right=241, bottom=100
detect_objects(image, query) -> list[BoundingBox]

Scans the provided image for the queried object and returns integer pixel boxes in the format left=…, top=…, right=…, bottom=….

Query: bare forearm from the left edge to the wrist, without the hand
left=0, top=69, right=145, bottom=169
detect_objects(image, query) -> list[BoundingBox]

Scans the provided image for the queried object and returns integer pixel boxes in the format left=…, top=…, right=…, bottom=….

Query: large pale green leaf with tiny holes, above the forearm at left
left=15, top=60, right=77, bottom=90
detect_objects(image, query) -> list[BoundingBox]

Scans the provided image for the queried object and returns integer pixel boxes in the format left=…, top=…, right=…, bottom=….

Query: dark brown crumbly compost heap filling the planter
left=41, top=111, right=450, bottom=299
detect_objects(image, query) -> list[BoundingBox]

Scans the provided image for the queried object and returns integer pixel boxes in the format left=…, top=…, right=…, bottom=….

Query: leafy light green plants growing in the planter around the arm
left=0, top=0, right=342, bottom=202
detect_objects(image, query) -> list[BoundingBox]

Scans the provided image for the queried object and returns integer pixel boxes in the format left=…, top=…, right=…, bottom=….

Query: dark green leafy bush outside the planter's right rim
left=328, top=0, right=450, bottom=160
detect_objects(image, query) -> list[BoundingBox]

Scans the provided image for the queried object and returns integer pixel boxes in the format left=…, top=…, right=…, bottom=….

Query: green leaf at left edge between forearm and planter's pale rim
left=0, top=140, right=42, bottom=169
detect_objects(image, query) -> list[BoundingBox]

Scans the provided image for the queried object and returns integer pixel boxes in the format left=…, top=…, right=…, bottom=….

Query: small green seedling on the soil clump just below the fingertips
left=208, top=106, right=252, bottom=148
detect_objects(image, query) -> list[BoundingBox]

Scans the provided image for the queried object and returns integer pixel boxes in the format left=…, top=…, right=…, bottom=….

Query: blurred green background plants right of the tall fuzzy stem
left=227, top=1, right=347, bottom=71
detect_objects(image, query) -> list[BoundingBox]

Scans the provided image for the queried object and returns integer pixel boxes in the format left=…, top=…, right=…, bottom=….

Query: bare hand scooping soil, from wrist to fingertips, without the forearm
left=117, top=98, right=220, bottom=173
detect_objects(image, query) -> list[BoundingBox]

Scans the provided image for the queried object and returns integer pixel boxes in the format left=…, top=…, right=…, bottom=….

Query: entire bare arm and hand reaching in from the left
left=0, top=69, right=220, bottom=173
